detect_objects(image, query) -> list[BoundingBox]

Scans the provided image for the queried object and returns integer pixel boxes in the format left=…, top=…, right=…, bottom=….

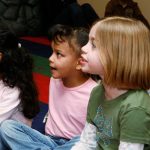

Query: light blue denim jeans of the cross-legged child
left=0, top=120, right=79, bottom=150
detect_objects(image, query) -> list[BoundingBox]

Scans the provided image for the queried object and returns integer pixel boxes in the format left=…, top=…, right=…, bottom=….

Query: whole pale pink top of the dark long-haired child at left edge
left=0, top=80, right=32, bottom=126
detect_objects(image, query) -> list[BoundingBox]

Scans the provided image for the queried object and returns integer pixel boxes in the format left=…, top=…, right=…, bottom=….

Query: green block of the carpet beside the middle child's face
left=32, top=55, right=51, bottom=76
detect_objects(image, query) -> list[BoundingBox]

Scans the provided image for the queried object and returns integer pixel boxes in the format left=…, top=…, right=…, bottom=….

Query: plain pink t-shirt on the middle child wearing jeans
left=45, top=78, right=97, bottom=139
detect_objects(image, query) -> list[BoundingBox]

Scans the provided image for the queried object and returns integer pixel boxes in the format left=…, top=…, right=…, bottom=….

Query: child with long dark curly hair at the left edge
left=0, top=20, right=39, bottom=126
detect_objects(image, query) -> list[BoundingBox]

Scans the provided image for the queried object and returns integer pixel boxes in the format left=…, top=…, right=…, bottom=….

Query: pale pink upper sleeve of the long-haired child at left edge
left=0, top=88, right=20, bottom=123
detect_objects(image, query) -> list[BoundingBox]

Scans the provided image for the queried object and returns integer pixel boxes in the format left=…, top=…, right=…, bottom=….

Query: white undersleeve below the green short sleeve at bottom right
left=119, top=141, right=144, bottom=150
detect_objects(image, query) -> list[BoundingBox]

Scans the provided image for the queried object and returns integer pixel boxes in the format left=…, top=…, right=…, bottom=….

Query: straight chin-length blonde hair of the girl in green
left=94, top=17, right=150, bottom=89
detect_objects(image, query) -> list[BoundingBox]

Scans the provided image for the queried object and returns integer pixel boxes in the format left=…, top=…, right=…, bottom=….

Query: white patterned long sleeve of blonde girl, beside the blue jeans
left=71, top=122, right=97, bottom=150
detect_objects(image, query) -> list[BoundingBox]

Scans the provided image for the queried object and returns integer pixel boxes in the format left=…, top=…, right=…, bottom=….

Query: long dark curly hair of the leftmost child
left=0, top=22, right=39, bottom=119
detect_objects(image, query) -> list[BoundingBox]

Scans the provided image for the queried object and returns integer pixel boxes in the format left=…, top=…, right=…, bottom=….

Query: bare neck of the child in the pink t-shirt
left=62, top=74, right=89, bottom=88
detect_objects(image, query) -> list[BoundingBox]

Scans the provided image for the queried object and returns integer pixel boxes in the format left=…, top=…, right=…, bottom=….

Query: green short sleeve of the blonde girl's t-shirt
left=120, top=108, right=150, bottom=144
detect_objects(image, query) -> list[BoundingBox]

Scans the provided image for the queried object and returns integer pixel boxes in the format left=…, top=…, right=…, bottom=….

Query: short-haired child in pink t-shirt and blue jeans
left=1, top=25, right=97, bottom=150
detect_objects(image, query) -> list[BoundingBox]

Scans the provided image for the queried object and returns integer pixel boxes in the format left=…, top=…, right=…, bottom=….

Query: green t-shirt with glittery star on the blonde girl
left=87, top=85, right=150, bottom=150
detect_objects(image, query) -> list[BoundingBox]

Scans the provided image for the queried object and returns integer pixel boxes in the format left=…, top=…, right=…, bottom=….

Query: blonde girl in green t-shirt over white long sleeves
left=71, top=17, right=150, bottom=150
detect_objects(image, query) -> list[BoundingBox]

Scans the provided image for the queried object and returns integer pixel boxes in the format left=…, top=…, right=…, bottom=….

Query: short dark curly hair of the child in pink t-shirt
left=48, top=24, right=89, bottom=55
